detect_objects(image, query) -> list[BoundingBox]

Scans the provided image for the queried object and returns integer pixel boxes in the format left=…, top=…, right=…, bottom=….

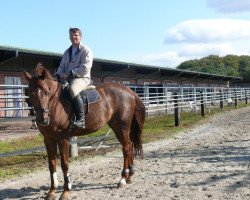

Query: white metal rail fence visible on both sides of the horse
left=0, top=85, right=250, bottom=118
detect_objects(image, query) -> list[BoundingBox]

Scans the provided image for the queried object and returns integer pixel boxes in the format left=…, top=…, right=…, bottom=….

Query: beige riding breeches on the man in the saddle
left=69, top=78, right=90, bottom=99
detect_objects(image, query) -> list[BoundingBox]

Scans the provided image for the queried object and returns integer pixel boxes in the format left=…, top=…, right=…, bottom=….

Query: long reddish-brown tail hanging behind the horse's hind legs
left=130, top=95, right=145, bottom=157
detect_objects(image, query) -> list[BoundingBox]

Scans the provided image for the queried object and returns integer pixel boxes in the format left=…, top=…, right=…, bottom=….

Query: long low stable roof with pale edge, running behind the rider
left=0, top=46, right=242, bottom=82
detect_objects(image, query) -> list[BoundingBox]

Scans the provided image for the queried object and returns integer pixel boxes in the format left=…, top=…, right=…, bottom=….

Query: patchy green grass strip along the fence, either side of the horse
left=0, top=103, right=250, bottom=180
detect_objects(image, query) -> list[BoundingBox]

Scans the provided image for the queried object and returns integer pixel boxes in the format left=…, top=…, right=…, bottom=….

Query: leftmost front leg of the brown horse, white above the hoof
left=44, top=137, right=58, bottom=200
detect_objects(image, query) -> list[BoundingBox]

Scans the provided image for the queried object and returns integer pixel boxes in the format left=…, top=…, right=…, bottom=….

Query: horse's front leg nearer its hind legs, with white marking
left=58, top=138, right=72, bottom=200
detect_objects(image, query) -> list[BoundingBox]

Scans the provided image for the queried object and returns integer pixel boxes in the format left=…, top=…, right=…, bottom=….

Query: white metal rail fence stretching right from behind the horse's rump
left=131, top=86, right=250, bottom=115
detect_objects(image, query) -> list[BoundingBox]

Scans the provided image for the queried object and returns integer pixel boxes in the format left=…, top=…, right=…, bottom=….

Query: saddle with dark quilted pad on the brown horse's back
left=62, top=84, right=102, bottom=114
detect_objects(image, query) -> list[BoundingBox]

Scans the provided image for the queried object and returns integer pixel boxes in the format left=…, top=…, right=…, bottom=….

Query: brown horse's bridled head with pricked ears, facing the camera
left=24, top=63, right=58, bottom=126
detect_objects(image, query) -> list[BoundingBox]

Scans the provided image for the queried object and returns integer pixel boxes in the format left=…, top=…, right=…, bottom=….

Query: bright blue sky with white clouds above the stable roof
left=0, top=0, right=250, bottom=68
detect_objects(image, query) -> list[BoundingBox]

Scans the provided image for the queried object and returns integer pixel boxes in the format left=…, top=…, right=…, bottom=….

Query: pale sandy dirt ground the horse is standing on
left=0, top=107, right=250, bottom=200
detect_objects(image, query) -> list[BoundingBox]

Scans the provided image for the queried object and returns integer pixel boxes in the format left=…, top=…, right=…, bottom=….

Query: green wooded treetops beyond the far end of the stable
left=177, top=55, right=250, bottom=82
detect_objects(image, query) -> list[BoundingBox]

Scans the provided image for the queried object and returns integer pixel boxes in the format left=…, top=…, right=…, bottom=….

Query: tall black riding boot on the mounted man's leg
left=72, top=94, right=85, bottom=128
